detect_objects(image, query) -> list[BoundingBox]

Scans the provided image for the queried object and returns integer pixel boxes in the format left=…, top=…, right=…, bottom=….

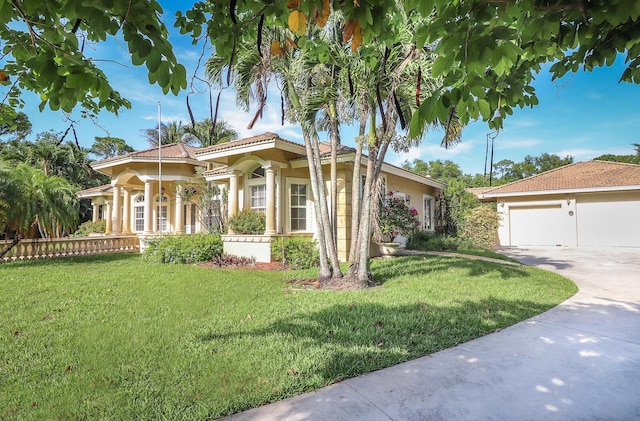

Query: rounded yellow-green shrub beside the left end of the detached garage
left=459, top=206, right=500, bottom=250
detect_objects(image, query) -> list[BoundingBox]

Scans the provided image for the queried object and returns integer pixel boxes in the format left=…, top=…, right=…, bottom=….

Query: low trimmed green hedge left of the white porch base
left=142, top=234, right=222, bottom=263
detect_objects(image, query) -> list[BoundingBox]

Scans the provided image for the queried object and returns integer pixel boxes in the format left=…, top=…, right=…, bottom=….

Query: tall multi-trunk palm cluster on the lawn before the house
left=207, top=2, right=460, bottom=286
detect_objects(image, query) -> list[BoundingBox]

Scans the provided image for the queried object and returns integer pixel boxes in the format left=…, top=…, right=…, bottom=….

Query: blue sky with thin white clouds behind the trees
left=15, top=1, right=640, bottom=174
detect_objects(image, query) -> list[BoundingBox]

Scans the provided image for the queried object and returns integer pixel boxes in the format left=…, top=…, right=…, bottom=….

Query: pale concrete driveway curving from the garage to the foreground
left=230, top=248, right=640, bottom=421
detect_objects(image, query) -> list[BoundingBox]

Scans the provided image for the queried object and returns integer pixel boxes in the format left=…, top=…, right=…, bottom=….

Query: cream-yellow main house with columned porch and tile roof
left=79, top=133, right=446, bottom=261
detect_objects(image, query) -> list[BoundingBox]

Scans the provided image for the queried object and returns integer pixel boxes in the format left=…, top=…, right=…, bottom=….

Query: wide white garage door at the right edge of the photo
left=576, top=192, right=640, bottom=247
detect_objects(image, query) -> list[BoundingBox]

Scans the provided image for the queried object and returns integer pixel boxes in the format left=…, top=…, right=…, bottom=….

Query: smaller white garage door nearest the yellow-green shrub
left=509, top=204, right=568, bottom=246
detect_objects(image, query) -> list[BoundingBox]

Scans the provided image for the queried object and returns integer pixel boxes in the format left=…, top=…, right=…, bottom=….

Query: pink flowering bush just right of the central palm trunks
left=378, top=192, right=420, bottom=242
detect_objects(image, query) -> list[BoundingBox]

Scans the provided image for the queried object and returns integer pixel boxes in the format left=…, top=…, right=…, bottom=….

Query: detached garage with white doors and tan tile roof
left=479, top=161, right=640, bottom=247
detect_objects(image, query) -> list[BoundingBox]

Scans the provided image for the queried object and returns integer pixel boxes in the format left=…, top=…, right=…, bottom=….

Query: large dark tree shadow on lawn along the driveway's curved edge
left=197, top=298, right=555, bottom=386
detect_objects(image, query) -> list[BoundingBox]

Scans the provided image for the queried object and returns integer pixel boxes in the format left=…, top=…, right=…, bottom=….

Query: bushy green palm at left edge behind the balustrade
left=0, top=163, right=78, bottom=257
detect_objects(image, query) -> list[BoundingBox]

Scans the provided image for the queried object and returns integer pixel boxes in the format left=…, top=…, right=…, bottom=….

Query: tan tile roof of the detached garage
left=485, top=161, right=640, bottom=196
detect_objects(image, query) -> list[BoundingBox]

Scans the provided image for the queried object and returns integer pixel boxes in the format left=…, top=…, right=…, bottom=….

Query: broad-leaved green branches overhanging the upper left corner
left=0, top=0, right=187, bottom=124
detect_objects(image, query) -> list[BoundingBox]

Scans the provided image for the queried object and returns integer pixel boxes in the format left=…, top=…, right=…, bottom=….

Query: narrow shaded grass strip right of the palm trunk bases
left=372, top=255, right=530, bottom=284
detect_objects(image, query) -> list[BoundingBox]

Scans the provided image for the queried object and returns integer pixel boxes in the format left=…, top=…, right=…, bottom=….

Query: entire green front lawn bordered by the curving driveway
left=0, top=251, right=576, bottom=420
